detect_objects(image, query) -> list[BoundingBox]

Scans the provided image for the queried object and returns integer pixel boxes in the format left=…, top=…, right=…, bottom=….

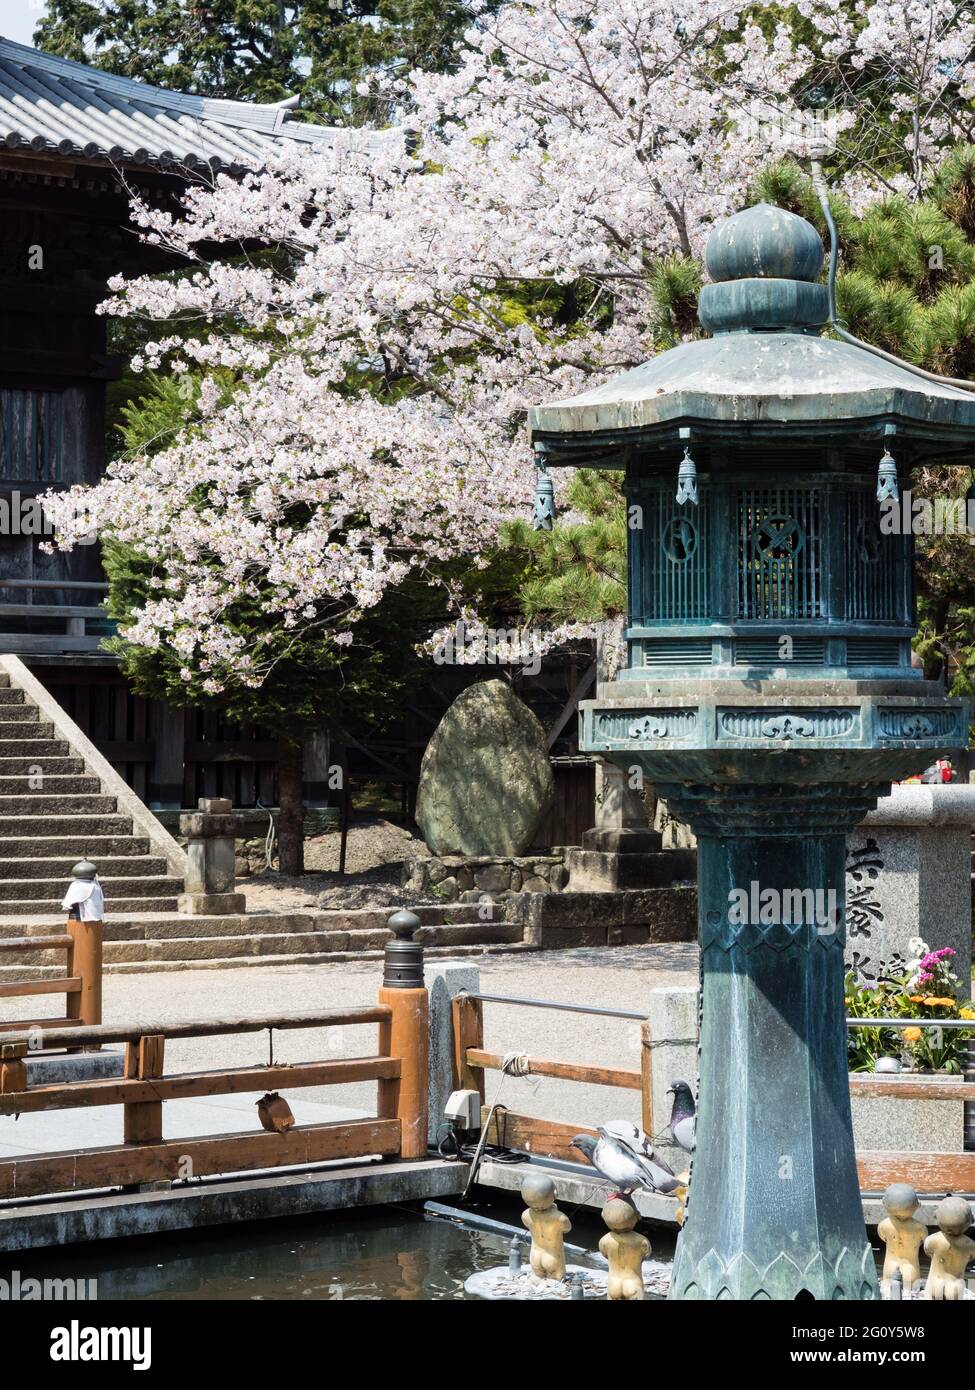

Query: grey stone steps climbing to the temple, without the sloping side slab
left=0, top=673, right=182, bottom=922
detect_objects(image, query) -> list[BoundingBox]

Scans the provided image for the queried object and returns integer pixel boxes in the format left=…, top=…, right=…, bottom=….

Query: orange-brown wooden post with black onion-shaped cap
left=378, top=912, right=430, bottom=1158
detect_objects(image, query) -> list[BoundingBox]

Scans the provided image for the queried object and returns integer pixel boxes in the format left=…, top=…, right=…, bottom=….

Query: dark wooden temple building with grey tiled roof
left=0, top=39, right=364, bottom=808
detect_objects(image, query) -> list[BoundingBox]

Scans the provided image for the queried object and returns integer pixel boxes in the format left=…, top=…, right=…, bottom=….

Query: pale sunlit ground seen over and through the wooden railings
left=0, top=945, right=697, bottom=1156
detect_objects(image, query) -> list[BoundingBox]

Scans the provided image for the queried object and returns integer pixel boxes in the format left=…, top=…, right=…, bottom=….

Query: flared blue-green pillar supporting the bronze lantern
left=668, top=788, right=879, bottom=1300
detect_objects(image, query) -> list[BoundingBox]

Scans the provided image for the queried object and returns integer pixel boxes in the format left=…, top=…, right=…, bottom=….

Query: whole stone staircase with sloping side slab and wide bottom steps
left=0, top=655, right=529, bottom=983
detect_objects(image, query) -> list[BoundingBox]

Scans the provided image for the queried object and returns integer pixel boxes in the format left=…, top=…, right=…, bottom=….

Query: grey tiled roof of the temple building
left=0, top=38, right=384, bottom=170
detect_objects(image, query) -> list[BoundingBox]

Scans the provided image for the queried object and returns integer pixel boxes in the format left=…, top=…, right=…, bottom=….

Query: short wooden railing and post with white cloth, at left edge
left=0, top=922, right=102, bottom=1047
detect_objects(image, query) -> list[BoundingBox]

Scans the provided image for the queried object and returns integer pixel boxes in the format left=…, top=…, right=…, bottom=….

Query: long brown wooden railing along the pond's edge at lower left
left=0, top=990, right=427, bottom=1198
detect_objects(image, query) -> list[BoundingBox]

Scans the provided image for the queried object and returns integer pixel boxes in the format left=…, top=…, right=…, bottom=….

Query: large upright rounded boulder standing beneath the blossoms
left=416, top=681, right=555, bottom=855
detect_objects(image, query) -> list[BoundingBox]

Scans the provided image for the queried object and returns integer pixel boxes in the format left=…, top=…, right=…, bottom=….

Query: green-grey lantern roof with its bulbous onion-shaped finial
left=529, top=203, right=975, bottom=461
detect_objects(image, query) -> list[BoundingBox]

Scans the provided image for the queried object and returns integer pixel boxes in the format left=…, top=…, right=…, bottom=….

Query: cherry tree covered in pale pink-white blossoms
left=47, top=0, right=975, bottom=695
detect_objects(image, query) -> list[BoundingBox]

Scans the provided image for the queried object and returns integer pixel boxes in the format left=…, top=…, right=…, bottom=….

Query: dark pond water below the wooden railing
left=0, top=1204, right=673, bottom=1301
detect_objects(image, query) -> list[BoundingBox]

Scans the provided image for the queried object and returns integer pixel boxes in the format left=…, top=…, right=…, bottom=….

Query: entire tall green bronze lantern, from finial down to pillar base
left=529, top=203, right=975, bottom=1300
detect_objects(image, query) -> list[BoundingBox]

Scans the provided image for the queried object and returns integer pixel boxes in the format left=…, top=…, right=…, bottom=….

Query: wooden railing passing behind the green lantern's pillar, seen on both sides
left=453, top=994, right=975, bottom=1193
